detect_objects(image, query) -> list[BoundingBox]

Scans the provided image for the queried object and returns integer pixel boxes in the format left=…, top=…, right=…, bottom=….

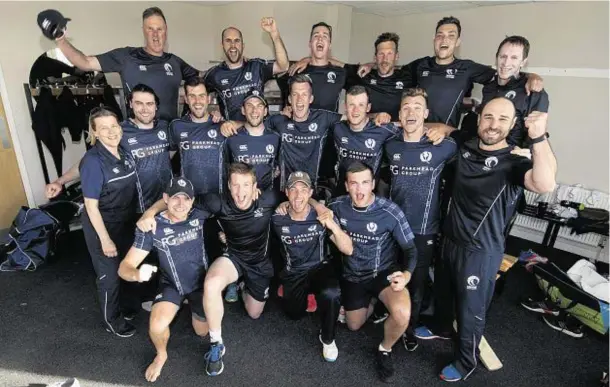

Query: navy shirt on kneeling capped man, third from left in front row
left=271, top=208, right=328, bottom=276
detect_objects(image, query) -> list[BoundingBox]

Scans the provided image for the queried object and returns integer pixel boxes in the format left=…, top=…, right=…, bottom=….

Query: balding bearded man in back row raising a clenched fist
left=204, top=17, right=289, bottom=121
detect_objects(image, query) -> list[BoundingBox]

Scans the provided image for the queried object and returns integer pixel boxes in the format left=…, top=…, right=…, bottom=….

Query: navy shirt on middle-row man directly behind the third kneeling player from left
left=266, top=109, right=341, bottom=190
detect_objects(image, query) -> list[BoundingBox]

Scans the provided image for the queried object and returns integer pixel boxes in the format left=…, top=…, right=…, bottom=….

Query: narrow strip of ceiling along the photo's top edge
left=313, top=0, right=533, bottom=17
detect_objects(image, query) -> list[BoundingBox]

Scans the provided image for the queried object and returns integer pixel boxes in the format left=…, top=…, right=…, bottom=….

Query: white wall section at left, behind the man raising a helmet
left=0, top=2, right=213, bottom=204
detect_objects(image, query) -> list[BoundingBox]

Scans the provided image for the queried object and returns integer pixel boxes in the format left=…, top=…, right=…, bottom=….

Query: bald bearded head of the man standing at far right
left=478, top=97, right=516, bottom=145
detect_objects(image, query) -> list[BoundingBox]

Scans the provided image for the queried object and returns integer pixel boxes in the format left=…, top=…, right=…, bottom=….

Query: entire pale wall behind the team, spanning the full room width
left=0, top=2, right=609, bottom=209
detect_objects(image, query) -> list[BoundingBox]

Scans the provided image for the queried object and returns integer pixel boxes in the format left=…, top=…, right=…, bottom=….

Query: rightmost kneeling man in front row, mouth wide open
left=329, top=161, right=417, bottom=382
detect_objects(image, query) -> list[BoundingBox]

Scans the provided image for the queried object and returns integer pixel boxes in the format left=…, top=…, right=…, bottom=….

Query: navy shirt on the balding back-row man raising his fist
left=204, top=58, right=273, bottom=121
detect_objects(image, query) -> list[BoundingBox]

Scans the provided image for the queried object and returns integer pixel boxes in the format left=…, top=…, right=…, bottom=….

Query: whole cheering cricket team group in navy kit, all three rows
left=41, top=7, right=557, bottom=382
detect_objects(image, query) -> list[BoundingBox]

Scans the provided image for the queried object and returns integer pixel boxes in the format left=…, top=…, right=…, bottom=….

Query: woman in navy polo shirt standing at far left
left=79, top=107, right=142, bottom=337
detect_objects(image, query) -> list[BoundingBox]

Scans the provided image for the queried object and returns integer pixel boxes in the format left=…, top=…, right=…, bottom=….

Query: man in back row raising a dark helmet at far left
left=56, top=7, right=199, bottom=120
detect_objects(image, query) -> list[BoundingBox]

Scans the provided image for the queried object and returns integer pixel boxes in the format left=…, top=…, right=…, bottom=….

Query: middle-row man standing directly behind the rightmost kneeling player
left=333, top=86, right=396, bottom=196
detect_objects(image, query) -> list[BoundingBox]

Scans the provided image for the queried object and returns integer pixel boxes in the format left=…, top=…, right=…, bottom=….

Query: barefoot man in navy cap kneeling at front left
left=119, top=177, right=209, bottom=382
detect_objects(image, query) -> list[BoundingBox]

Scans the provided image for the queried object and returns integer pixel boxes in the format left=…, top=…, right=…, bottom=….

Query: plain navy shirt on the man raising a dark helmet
left=95, top=47, right=199, bottom=121
